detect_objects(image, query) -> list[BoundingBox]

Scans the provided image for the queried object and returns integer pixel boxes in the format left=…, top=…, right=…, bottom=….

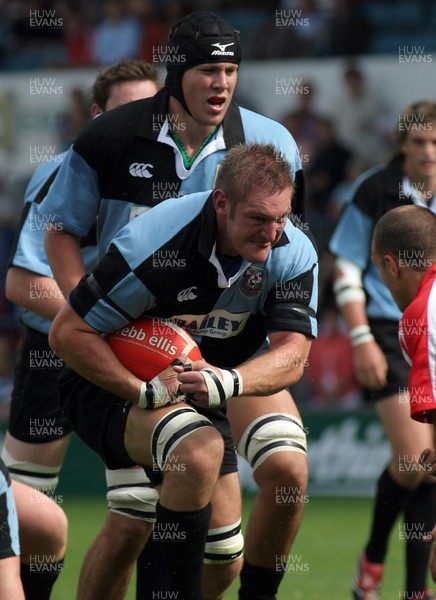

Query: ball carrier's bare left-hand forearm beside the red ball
left=49, top=304, right=142, bottom=404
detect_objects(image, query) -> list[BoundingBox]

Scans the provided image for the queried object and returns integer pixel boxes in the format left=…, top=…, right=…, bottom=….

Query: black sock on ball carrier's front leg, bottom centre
left=156, top=502, right=211, bottom=600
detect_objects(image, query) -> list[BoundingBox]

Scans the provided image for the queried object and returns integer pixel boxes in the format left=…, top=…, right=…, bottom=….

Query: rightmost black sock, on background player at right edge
left=404, top=483, right=436, bottom=592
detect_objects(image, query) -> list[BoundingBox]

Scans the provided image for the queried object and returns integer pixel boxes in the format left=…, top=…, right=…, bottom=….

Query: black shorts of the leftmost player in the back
left=8, top=327, right=72, bottom=444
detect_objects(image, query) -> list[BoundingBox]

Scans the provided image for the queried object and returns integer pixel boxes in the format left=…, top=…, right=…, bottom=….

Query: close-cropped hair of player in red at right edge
left=373, top=205, right=436, bottom=271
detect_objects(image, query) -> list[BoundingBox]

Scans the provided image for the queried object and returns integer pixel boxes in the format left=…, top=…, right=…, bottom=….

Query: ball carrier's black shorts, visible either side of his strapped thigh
left=58, top=367, right=238, bottom=483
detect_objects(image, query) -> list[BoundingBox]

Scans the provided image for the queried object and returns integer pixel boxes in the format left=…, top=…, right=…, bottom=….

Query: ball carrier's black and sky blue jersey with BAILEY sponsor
left=69, top=191, right=318, bottom=367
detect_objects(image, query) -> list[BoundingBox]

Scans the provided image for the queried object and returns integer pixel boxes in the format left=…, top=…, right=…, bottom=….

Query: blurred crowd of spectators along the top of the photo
left=0, top=0, right=436, bottom=70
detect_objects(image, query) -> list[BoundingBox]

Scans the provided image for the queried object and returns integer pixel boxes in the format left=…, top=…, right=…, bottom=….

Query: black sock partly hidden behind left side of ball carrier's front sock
left=136, top=533, right=172, bottom=600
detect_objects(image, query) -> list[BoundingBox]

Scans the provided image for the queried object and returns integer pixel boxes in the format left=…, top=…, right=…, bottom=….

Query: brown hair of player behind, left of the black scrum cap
left=92, top=59, right=161, bottom=110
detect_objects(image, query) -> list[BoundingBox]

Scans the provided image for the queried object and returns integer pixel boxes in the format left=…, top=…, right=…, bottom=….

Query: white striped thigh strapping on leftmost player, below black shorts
left=2, top=448, right=61, bottom=495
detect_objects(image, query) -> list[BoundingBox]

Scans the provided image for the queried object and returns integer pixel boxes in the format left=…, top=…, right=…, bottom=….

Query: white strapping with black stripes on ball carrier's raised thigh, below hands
left=150, top=407, right=217, bottom=472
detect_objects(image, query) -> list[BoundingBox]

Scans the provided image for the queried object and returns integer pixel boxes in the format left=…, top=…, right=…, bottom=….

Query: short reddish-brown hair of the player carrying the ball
left=214, top=144, right=294, bottom=203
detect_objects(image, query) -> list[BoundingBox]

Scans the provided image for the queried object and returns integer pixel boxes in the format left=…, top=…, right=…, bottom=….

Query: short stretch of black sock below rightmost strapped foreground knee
left=239, top=560, right=285, bottom=600
